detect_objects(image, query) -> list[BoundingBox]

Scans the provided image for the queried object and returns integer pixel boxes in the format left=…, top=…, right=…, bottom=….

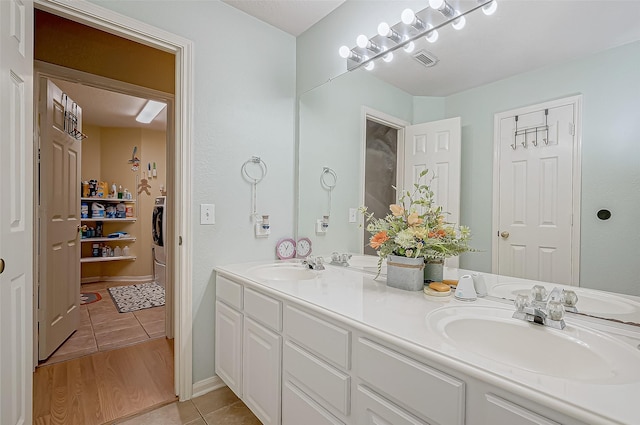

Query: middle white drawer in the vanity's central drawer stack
left=282, top=341, right=351, bottom=415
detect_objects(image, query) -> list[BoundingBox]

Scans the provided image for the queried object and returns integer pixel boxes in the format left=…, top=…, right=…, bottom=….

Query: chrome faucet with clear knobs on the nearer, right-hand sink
left=513, top=285, right=578, bottom=329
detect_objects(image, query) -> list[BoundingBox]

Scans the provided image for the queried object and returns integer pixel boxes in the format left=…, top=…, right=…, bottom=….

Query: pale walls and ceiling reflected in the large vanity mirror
left=297, top=1, right=640, bottom=304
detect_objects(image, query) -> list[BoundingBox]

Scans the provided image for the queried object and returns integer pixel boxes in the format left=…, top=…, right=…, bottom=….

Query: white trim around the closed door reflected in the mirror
left=491, top=95, right=582, bottom=286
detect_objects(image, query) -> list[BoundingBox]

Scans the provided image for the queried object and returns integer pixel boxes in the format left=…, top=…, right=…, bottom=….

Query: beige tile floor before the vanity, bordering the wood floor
left=115, top=387, right=261, bottom=425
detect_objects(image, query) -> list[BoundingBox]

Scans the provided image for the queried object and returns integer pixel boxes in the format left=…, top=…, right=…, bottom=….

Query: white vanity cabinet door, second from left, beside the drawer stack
left=244, top=317, right=282, bottom=425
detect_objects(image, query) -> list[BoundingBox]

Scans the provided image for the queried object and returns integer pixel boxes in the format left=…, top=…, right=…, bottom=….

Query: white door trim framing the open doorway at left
left=34, top=0, right=193, bottom=401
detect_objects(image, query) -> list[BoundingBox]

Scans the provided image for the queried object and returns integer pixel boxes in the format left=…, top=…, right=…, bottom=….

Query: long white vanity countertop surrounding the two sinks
left=216, top=257, right=640, bottom=425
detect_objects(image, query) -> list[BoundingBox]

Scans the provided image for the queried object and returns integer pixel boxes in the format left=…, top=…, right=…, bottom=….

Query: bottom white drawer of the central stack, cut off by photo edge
left=282, top=381, right=344, bottom=425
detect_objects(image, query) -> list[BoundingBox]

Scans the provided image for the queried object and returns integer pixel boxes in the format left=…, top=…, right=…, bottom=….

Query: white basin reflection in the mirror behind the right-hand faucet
left=489, top=283, right=640, bottom=322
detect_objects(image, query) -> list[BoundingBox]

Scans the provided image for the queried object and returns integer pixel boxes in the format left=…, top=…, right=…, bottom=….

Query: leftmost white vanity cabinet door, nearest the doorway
left=215, top=301, right=242, bottom=398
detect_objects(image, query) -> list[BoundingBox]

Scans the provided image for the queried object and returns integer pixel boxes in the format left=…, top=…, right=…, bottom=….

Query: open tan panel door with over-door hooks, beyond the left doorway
left=38, top=78, right=82, bottom=360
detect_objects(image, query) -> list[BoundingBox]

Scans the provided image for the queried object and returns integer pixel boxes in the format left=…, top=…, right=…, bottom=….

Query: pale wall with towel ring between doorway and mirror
left=94, top=0, right=295, bottom=382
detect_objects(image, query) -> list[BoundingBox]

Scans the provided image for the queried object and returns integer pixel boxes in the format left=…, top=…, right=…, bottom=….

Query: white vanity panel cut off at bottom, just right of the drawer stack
left=355, top=385, right=429, bottom=425
